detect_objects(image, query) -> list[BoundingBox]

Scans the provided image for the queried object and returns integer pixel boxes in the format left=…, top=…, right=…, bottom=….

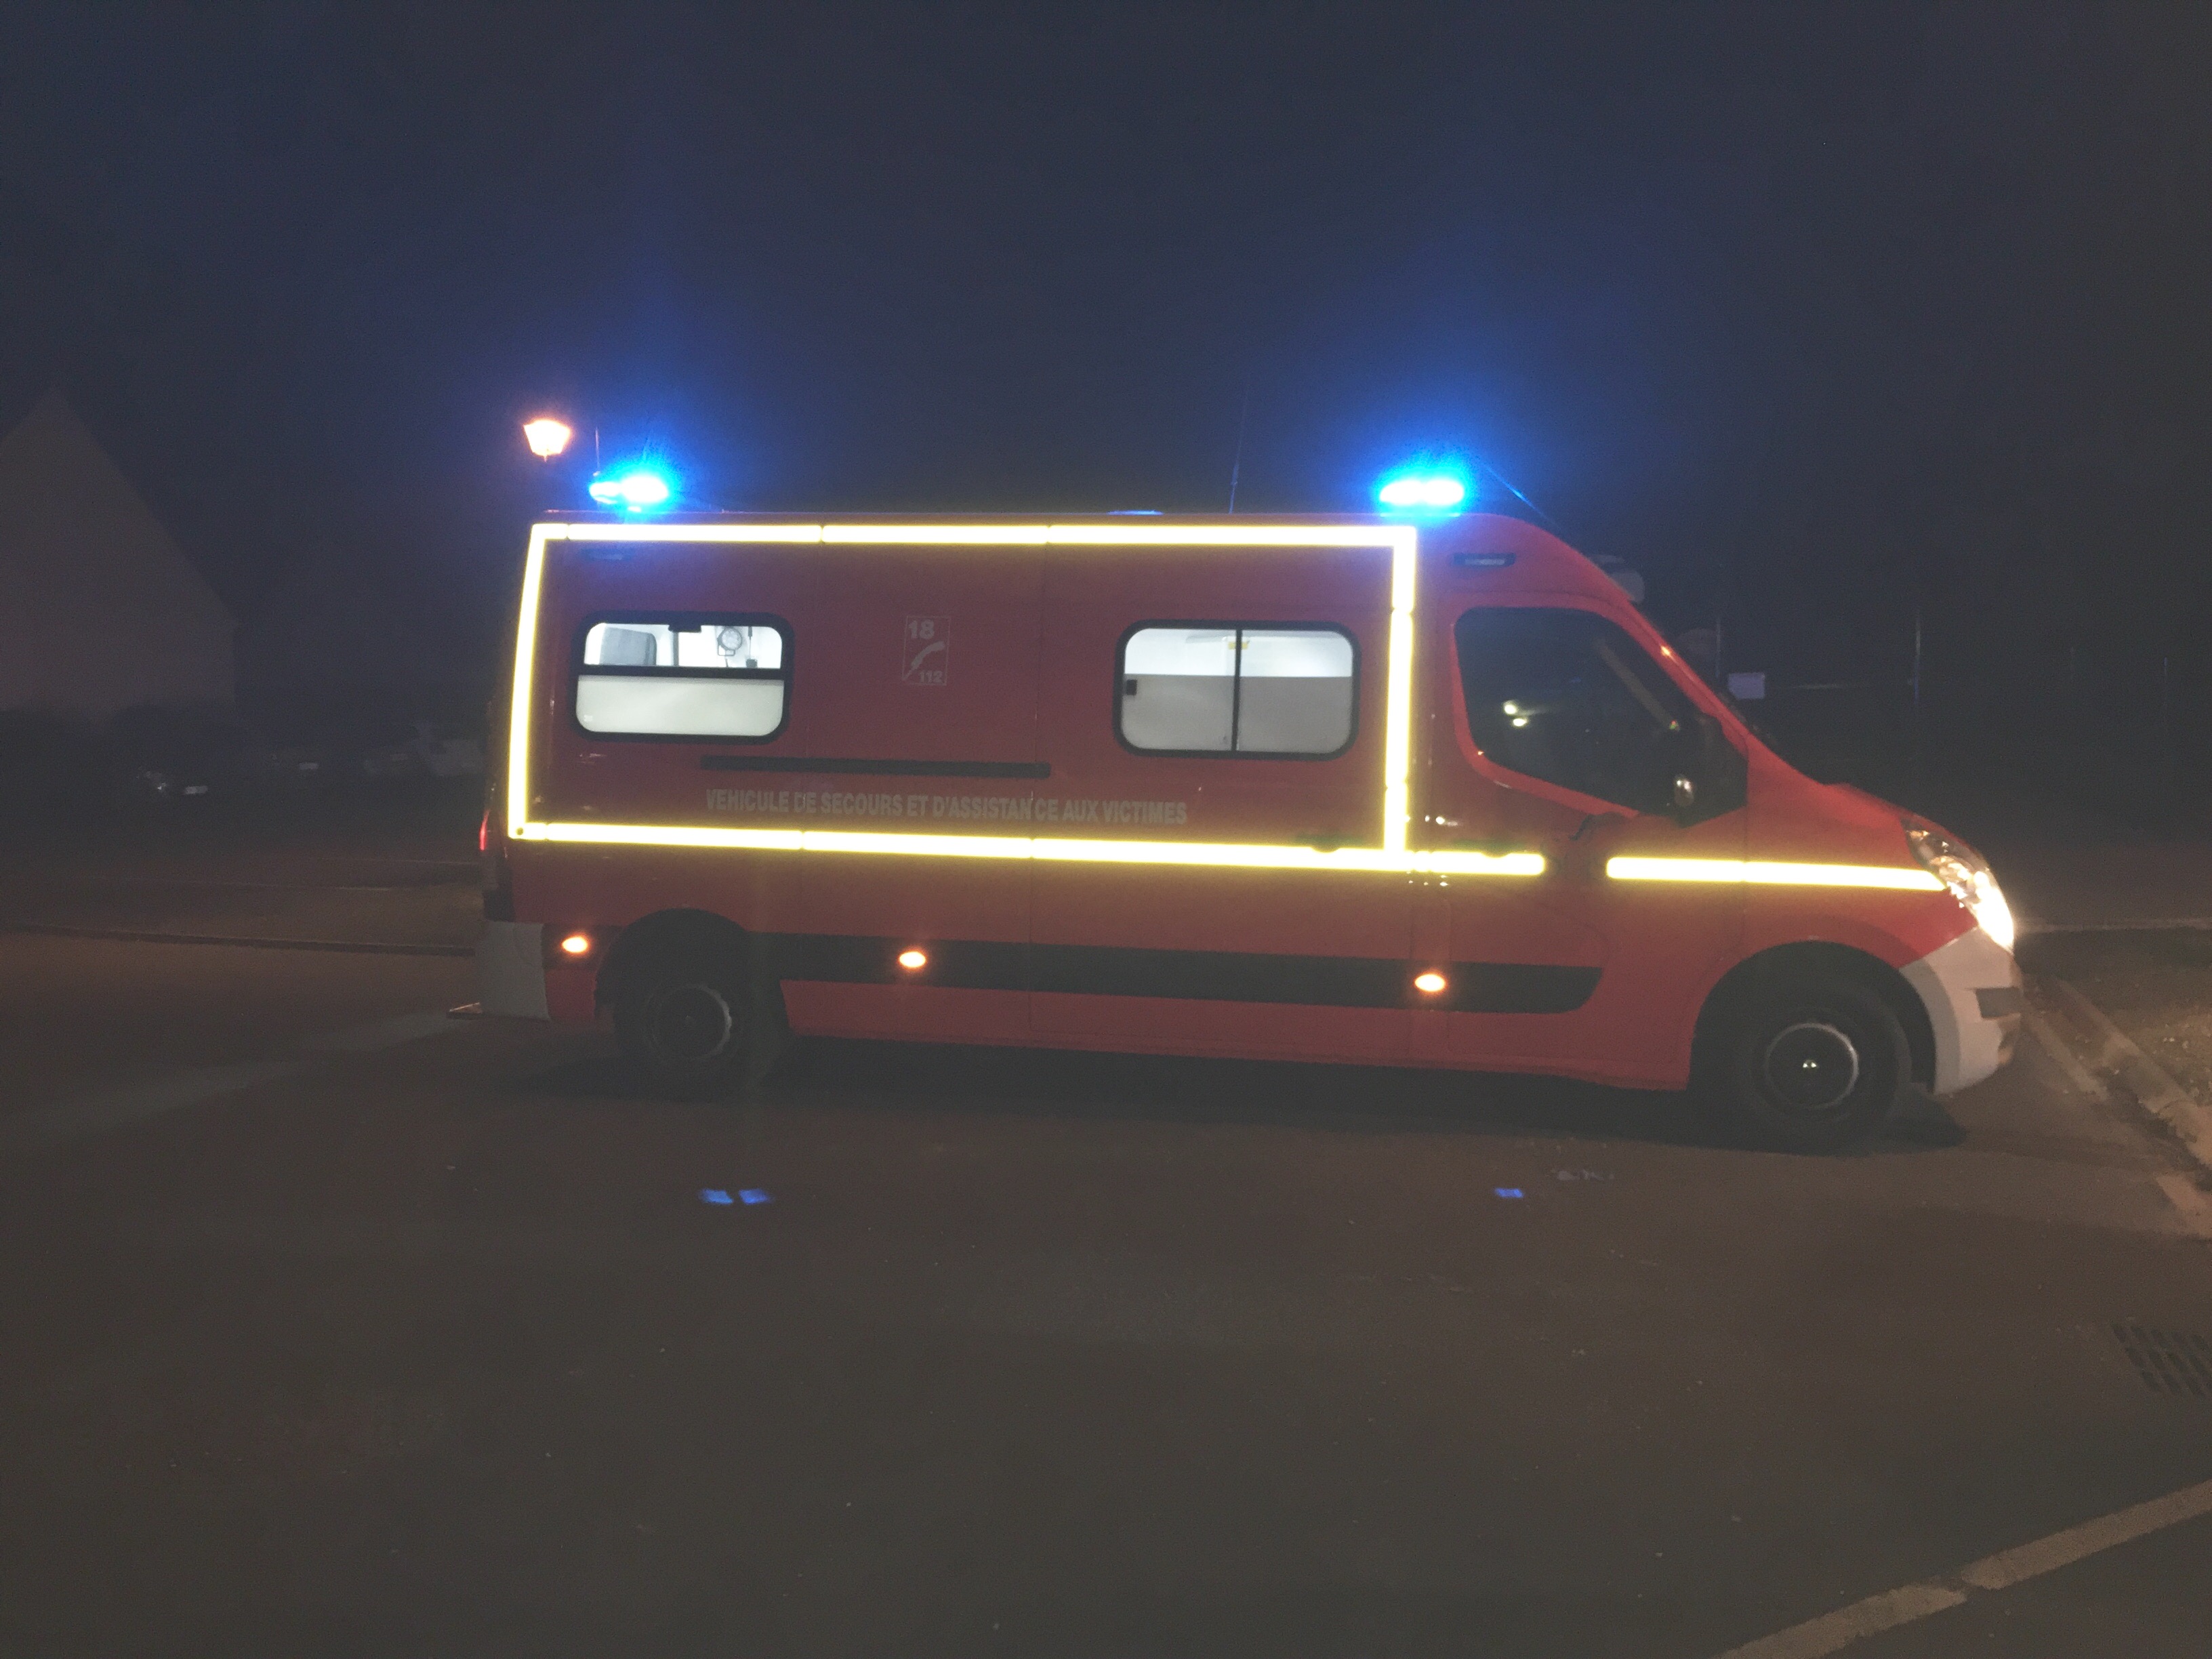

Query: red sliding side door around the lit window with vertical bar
left=1031, top=548, right=1411, bottom=1059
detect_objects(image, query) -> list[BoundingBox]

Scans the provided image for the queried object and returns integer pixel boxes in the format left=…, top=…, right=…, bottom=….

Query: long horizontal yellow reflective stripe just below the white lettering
left=516, top=823, right=1544, bottom=876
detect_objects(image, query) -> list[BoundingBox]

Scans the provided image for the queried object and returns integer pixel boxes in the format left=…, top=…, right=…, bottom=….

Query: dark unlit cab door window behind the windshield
left=1453, top=609, right=1696, bottom=812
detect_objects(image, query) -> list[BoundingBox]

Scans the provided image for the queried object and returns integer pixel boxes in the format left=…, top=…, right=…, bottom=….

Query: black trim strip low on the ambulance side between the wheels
left=772, top=933, right=1599, bottom=1013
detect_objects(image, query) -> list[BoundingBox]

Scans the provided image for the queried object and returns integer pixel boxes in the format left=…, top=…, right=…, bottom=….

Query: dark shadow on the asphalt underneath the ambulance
left=516, top=1038, right=1960, bottom=1157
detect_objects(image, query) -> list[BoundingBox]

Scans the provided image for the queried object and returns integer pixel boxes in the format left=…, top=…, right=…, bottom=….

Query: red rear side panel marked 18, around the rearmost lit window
left=533, top=542, right=1042, bottom=1042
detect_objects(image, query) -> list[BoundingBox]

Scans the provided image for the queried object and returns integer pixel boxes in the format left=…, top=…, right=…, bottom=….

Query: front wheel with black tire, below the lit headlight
left=1699, top=973, right=1911, bottom=1153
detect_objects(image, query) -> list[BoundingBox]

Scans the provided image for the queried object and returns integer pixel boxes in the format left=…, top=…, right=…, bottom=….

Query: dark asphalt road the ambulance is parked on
left=0, top=814, right=2212, bottom=1659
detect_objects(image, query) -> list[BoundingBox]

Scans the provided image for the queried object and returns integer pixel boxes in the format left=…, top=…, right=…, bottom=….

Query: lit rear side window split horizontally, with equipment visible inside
left=575, top=615, right=790, bottom=739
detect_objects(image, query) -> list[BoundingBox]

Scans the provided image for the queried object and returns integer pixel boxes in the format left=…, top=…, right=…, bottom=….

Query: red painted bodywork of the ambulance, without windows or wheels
left=506, top=516, right=1971, bottom=1086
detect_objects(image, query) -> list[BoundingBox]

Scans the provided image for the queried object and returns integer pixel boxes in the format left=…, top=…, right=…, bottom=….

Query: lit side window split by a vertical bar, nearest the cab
left=1115, top=621, right=1358, bottom=761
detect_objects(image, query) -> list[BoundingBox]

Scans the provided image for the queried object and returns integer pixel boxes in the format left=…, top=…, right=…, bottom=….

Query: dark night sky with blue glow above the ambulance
left=0, top=0, right=2212, bottom=703
